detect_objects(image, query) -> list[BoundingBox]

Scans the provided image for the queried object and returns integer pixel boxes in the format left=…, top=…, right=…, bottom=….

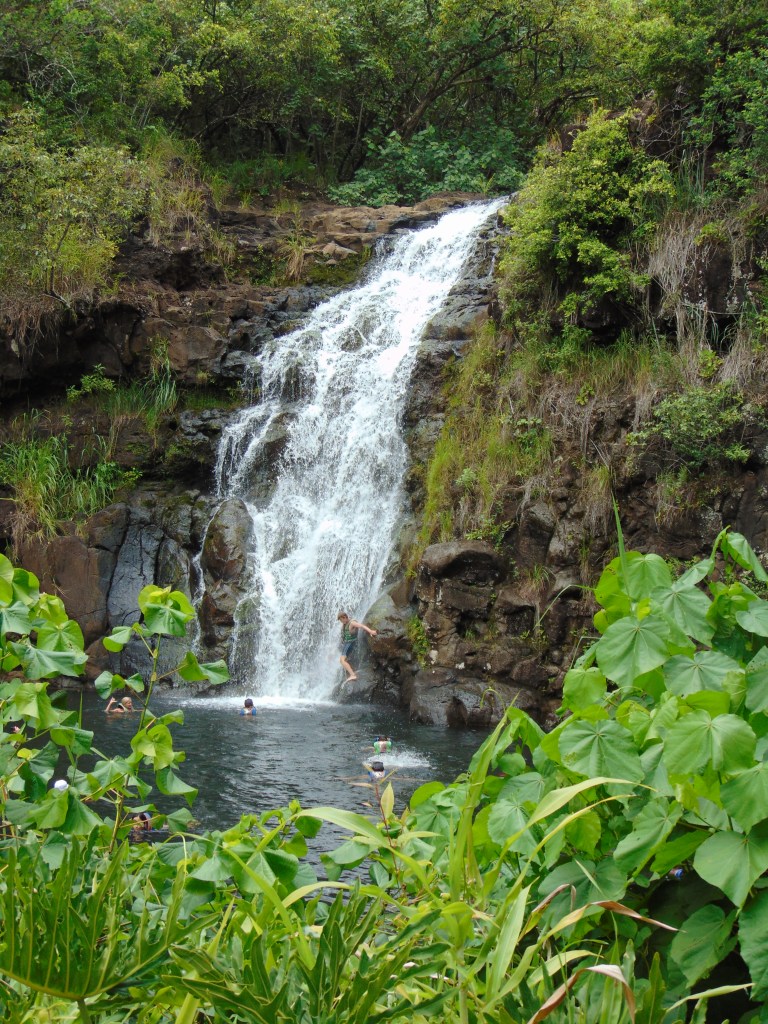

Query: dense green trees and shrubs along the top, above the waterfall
left=0, top=0, right=768, bottom=325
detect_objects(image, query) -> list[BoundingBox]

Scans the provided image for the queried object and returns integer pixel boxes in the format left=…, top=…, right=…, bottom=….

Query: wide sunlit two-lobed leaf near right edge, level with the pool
left=664, top=711, right=757, bottom=775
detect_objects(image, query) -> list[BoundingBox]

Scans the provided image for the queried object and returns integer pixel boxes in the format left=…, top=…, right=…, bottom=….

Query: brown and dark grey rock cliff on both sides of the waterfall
left=0, top=197, right=768, bottom=726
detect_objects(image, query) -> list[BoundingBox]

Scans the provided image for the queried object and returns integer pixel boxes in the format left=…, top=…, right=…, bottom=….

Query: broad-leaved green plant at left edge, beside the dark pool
left=0, top=555, right=228, bottom=839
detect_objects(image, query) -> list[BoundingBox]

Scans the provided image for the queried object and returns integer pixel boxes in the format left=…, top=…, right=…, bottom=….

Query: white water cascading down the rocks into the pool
left=217, top=201, right=501, bottom=699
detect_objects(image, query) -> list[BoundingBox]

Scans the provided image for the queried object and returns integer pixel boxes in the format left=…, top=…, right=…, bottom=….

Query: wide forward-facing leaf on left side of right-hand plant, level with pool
left=560, top=719, right=643, bottom=781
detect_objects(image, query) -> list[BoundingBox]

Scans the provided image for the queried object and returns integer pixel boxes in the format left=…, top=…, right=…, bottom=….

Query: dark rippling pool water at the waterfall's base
left=83, top=693, right=485, bottom=828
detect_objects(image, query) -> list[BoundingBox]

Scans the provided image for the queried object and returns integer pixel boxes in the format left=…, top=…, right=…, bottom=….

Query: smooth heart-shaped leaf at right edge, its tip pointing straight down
left=693, top=822, right=768, bottom=906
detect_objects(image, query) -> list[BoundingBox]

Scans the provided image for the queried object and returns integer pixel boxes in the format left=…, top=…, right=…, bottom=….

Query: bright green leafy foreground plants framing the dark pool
left=0, top=530, right=768, bottom=1024
